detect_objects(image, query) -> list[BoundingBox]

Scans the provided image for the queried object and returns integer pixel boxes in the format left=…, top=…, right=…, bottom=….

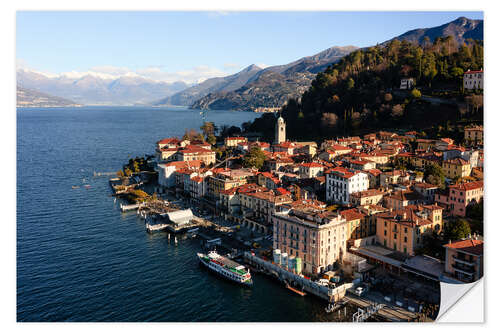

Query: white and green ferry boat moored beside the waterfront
left=197, top=251, right=253, bottom=286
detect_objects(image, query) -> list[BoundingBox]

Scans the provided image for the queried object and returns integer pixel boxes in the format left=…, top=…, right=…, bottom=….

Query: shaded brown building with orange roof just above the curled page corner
left=444, top=238, right=483, bottom=283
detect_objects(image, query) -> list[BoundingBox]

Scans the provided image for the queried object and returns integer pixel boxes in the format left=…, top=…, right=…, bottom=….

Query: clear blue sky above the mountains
left=16, top=11, right=483, bottom=83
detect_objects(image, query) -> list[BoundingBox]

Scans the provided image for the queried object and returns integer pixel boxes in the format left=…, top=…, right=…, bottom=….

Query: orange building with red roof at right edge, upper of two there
left=435, top=180, right=484, bottom=216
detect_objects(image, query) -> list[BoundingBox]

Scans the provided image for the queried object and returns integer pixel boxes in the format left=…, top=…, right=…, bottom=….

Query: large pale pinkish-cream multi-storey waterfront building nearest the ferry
left=272, top=206, right=347, bottom=274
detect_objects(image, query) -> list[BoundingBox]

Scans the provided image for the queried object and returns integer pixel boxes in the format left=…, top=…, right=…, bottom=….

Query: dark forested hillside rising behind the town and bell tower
left=245, top=36, right=483, bottom=140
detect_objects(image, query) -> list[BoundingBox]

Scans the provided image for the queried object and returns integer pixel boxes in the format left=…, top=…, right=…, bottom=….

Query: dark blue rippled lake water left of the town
left=17, top=107, right=354, bottom=322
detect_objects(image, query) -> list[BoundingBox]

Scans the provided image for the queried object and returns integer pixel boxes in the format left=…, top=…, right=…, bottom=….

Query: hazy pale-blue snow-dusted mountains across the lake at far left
left=17, top=69, right=188, bottom=105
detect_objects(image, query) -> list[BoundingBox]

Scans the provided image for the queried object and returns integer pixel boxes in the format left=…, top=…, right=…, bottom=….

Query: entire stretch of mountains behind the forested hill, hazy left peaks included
left=17, top=17, right=483, bottom=110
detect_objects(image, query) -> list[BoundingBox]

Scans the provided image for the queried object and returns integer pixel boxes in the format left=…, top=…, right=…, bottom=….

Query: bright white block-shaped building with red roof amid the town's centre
left=325, top=167, right=369, bottom=205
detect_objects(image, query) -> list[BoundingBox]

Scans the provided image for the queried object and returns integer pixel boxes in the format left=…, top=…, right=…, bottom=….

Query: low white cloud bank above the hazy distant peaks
left=16, top=59, right=231, bottom=84
